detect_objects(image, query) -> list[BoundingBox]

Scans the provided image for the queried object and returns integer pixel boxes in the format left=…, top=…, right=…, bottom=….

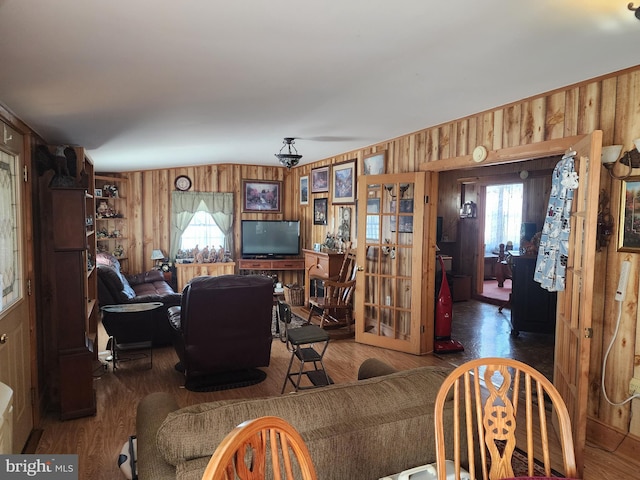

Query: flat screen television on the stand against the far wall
left=241, top=220, right=300, bottom=258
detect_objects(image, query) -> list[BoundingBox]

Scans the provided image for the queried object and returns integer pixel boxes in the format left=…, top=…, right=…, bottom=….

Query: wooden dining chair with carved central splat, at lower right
left=434, top=358, right=577, bottom=480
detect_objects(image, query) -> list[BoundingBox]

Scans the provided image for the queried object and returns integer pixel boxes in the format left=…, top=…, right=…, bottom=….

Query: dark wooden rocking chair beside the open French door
left=307, top=248, right=357, bottom=332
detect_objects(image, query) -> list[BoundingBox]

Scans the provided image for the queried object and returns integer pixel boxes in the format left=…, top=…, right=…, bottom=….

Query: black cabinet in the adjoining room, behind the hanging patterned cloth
left=511, top=254, right=557, bottom=335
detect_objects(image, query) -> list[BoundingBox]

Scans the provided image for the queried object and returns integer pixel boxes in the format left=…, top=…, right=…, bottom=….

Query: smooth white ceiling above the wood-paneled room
left=0, top=0, right=640, bottom=172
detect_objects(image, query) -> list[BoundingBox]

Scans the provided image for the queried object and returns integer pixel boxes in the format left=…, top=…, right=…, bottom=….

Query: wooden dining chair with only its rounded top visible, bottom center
left=202, top=417, right=317, bottom=480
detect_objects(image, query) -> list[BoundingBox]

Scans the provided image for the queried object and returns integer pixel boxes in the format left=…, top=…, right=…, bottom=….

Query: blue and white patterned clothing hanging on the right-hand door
left=533, top=150, right=578, bottom=292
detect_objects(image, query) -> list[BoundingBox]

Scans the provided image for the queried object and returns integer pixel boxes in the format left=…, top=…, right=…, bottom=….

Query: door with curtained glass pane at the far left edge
left=0, top=122, right=33, bottom=453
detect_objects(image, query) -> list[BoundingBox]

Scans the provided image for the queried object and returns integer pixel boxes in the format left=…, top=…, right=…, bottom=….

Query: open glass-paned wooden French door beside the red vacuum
left=355, top=172, right=435, bottom=354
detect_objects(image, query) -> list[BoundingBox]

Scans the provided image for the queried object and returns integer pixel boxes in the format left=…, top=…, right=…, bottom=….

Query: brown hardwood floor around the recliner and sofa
left=35, top=308, right=640, bottom=480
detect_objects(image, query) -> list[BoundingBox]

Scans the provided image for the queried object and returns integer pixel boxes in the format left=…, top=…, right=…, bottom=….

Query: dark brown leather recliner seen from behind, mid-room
left=168, top=275, right=273, bottom=380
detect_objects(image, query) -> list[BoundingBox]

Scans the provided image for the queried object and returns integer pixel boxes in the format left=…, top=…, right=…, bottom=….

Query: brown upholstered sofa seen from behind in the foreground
left=136, top=359, right=462, bottom=480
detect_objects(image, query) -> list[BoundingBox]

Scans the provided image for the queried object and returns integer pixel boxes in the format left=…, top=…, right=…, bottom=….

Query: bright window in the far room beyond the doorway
left=484, top=183, right=523, bottom=255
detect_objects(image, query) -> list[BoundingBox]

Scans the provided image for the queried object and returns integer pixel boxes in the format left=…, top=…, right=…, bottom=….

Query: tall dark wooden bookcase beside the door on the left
left=38, top=147, right=99, bottom=420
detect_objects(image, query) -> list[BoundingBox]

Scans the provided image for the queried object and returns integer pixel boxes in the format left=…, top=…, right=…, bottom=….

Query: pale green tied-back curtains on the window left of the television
left=169, top=192, right=233, bottom=259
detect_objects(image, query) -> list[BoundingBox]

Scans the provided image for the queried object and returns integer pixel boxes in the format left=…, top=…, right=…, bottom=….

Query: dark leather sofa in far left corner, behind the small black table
left=96, top=252, right=182, bottom=346
